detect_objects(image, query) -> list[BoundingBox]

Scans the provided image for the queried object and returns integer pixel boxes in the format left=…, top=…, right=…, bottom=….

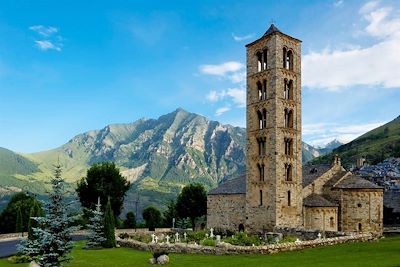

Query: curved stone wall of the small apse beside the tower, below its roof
left=304, top=207, right=338, bottom=231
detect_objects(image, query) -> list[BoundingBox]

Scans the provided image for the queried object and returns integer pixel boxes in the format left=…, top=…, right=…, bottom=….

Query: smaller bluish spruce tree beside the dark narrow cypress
left=85, top=198, right=106, bottom=248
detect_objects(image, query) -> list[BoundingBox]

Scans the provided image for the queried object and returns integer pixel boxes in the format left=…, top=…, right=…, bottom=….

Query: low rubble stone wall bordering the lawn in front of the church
left=117, top=234, right=375, bottom=255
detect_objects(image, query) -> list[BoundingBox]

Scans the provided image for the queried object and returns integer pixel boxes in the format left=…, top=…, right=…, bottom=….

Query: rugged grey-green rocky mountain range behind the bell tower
left=0, top=109, right=342, bottom=216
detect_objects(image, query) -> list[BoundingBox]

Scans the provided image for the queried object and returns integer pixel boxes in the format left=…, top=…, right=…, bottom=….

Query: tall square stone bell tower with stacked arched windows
left=246, top=24, right=303, bottom=231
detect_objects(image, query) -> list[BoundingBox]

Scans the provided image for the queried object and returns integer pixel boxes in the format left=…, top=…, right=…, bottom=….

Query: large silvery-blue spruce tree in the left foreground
left=19, top=165, right=78, bottom=267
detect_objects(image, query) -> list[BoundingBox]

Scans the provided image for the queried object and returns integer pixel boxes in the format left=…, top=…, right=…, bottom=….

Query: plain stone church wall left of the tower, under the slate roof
left=207, top=194, right=246, bottom=231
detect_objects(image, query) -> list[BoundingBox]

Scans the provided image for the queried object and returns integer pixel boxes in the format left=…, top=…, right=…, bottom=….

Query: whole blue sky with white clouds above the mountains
left=0, top=0, right=400, bottom=152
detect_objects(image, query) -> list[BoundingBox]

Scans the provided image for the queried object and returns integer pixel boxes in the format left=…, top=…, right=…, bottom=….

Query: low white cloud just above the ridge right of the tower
left=303, top=122, right=385, bottom=147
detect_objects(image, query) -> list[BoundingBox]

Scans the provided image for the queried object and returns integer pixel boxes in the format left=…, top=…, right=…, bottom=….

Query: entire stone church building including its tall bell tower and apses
left=207, top=24, right=383, bottom=233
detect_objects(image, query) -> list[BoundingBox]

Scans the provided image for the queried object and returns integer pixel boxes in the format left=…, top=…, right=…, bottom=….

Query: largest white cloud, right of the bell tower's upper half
left=302, top=2, right=400, bottom=90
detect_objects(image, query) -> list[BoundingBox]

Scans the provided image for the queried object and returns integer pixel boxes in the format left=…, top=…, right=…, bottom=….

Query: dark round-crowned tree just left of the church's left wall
left=176, top=184, right=207, bottom=228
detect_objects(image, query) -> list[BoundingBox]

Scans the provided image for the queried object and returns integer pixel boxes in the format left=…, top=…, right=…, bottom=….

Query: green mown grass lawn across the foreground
left=0, top=237, right=400, bottom=267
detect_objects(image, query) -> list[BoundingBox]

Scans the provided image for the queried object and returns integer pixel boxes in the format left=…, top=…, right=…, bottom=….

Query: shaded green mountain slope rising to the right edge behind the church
left=312, top=116, right=400, bottom=165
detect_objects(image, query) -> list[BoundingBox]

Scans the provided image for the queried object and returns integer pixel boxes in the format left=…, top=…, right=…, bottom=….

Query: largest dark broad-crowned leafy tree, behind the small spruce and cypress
left=76, top=162, right=131, bottom=217
